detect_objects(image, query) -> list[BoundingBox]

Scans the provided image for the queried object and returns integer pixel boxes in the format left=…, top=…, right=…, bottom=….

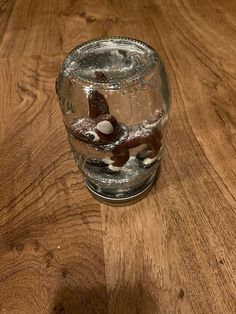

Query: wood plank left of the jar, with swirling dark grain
left=0, top=1, right=107, bottom=314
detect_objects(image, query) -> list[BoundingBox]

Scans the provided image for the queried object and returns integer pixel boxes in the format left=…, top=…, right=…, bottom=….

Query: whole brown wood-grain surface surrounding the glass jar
left=0, top=0, right=236, bottom=314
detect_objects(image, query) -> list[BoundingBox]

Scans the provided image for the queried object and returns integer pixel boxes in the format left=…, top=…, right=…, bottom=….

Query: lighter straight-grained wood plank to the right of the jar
left=84, top=1, right=236, bottom=313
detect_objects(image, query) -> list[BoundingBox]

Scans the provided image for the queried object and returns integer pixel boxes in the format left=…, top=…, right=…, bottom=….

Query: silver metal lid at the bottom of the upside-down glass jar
left=84, top=169, right=160, bottom=206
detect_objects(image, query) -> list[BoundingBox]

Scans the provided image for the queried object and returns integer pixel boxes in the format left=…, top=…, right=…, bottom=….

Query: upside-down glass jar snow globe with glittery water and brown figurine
left=56, top=37, right=169, bottom=205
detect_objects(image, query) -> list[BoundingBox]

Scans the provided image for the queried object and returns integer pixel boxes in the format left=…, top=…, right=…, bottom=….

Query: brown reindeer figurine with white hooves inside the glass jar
left=71, top=90, right=163, bottom=173
